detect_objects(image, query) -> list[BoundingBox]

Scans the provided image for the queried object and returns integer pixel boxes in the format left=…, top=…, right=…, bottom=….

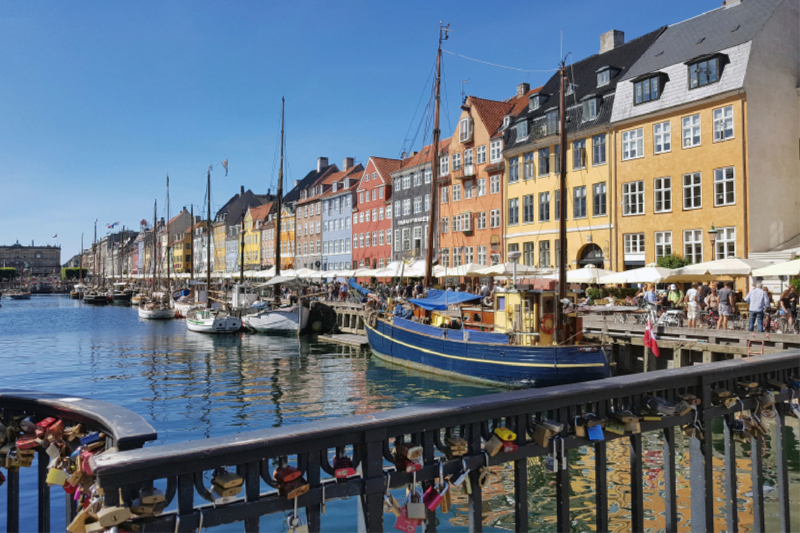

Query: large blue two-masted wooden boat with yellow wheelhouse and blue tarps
left=360, top=25, right=612, bottom=387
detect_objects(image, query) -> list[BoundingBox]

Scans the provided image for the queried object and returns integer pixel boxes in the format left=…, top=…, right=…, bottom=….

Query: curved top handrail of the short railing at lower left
left=0, top=388, right=158, bottom=451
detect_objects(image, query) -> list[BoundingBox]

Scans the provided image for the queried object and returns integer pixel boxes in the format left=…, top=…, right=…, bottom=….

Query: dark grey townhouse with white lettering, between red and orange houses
left=392, top=138, right=450, bottom=260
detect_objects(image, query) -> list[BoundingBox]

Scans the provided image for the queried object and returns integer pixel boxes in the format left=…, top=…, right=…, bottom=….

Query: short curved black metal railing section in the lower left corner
left=0, top=389, right=157, bottom=533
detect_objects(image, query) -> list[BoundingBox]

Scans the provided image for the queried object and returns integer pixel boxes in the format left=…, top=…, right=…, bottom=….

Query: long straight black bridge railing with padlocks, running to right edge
left=87, top=351, right=800, bottom=532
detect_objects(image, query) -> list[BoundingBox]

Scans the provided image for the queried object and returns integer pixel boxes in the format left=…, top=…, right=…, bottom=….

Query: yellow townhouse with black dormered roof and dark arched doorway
left=501, top=28, right=664, bottom=268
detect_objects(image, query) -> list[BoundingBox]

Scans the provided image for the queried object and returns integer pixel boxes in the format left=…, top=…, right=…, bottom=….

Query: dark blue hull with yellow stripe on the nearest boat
left=366, top=320, right=611, bottom=387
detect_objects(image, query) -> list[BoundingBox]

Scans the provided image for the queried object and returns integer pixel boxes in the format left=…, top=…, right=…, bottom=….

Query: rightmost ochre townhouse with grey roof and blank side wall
left=610, top=0, right=800, bottom=270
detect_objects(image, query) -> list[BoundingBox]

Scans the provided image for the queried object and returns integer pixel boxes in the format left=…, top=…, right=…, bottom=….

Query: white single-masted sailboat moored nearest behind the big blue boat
left=242, top=98, right=309, bottom=334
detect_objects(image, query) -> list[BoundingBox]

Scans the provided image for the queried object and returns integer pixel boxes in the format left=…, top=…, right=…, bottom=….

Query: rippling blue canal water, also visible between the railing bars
left=0, top=296, right=800, bottom=532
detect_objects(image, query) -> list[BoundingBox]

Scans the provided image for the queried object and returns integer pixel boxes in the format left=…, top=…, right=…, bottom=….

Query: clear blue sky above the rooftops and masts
left=0, top=0, right=720, bottom=261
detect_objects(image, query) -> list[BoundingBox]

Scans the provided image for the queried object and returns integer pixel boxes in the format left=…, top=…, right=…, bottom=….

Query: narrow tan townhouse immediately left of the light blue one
left=287, top=157, right=339, bottom=270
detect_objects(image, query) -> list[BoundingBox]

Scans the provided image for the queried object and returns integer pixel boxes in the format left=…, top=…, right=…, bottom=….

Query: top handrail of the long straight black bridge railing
left=93, top=350, right=800, bottom=484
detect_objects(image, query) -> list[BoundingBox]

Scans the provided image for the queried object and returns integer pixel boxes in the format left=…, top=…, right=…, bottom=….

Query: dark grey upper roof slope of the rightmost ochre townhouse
left=620, top=0, right=783, bottom=80
